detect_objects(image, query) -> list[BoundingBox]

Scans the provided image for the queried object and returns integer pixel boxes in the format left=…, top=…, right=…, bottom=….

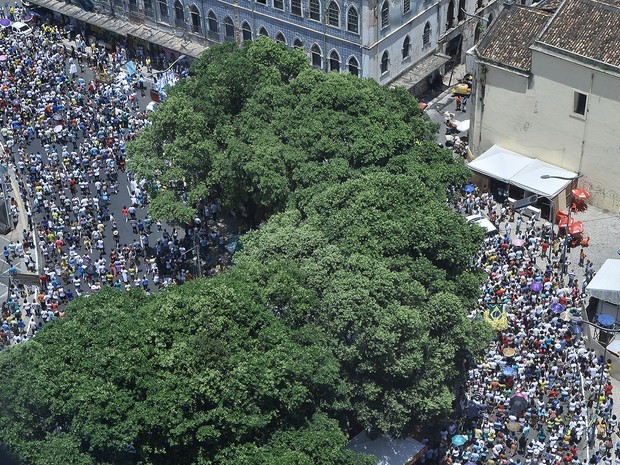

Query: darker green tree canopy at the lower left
left=0, top=277, right=354, bottom=465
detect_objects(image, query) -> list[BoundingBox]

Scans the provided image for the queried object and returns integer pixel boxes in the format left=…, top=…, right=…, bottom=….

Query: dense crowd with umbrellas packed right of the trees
left=442, top=188, right=620, bottom=465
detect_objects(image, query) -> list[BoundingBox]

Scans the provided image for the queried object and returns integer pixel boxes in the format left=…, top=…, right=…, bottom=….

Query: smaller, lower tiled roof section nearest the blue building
left=477, top=5, right=551, bottom=71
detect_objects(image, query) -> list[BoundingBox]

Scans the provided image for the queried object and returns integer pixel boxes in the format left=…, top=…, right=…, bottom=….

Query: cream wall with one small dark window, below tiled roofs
left=471, top=50, right=620, bottom=213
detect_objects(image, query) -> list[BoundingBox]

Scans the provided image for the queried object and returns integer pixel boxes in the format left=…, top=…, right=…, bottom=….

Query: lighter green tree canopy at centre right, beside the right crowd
left=233, top=198, right=490, bottom=435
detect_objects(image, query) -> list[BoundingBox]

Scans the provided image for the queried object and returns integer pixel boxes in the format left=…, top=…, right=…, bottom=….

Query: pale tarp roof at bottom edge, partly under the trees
left=347, top=431, right=424, bottom=465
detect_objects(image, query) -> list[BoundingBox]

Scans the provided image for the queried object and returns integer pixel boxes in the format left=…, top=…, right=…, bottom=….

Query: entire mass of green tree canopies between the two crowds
left=0, top=40, right=489, bottom=465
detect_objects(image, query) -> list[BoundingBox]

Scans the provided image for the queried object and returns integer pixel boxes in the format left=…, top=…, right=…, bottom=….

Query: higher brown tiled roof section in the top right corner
left=538, top=0, right=620, bottom=66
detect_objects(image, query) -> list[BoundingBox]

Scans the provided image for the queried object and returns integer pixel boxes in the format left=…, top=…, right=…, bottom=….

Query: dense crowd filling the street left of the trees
left=0, top=12, right=225, bottom=345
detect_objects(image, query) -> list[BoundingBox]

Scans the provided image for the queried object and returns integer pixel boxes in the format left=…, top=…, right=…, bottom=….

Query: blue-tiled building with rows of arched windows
left=33, top=0, right=512, bottom=87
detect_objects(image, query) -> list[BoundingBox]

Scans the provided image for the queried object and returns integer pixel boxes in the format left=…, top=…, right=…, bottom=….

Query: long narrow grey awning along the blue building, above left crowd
left=31, top=0, right=208, bottom=58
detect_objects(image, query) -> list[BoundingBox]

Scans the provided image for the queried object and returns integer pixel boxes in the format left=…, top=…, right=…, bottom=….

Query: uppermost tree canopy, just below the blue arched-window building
left=128, top=39, right=440, bottom=224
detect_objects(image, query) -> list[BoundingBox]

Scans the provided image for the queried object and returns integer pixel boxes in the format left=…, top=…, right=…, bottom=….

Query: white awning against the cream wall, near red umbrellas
left=468, top=145, right=577, bottom=199
